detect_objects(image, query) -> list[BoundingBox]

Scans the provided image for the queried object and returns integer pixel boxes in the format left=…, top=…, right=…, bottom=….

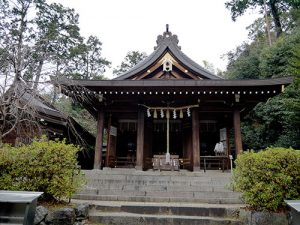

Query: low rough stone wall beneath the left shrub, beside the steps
left=34, top=204, right=89, bottom=225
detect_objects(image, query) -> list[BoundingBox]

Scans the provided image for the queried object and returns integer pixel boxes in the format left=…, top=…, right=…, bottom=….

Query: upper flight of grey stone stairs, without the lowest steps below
left=73, top=169, right=241, bottom=204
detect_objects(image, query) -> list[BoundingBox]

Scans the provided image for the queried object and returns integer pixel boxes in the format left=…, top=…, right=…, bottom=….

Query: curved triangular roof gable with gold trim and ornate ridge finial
left=115, top=26, right=222, bottom=80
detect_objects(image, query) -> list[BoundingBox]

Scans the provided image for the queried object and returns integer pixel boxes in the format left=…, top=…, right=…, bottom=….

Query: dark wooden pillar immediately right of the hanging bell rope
left=192, top=108, right=200, bottom=171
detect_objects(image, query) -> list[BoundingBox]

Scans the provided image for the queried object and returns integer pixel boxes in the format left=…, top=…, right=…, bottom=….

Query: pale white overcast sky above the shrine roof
left=48, top=0, right=258, bottom=78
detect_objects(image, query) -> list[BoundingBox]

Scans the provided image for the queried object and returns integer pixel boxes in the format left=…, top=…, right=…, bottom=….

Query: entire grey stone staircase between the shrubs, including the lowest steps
left=72, top=169, right=242, bottom=225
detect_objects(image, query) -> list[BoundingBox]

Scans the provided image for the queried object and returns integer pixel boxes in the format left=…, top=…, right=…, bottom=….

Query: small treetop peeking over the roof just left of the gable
left=113, top=51, right=147, bottom=76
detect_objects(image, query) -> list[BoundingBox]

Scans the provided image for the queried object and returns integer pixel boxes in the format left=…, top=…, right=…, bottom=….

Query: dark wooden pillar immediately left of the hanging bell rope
left=135, top=109, right=145, bottom=170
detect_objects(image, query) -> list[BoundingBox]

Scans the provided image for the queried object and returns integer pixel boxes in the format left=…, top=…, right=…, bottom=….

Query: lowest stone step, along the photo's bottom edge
left=89, top=212, right=241, bottom=225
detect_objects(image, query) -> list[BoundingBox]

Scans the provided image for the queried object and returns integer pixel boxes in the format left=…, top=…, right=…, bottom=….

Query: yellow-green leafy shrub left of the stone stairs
left=0, top=138, right=83, bottom=200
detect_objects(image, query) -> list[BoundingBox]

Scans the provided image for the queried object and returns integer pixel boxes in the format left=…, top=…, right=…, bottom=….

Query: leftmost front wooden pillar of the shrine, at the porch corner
left=94, top=110, right=104, bottom=169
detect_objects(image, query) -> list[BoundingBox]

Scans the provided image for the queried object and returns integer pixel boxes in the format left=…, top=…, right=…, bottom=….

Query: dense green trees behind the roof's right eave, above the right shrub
left=226, top=21, right=300, bottom=149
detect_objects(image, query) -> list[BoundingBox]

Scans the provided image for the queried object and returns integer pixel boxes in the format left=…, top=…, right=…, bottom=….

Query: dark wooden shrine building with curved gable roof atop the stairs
left=53, top=27, right=291, bottom=171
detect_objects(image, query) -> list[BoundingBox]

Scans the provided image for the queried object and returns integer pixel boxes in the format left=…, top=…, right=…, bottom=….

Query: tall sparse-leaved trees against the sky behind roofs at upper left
left=0, top=0, right=110, bottom=89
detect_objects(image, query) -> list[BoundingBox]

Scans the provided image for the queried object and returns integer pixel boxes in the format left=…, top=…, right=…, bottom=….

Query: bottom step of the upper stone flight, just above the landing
left=73, top=194, right=241, bottom=204
